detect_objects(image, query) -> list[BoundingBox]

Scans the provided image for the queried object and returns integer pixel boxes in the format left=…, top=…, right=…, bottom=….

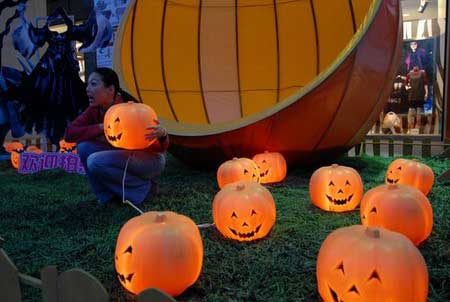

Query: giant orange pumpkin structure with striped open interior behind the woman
left=114, top=0, right=401, bottom=166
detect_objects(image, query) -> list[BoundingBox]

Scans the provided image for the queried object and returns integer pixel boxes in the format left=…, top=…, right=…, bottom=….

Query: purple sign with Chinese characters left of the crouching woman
left=18, top=152, right=85, bottom=174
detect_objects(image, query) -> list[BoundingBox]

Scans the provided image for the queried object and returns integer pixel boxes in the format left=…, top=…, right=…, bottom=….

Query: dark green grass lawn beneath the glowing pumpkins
left=0, top=157, right=450, bottom=302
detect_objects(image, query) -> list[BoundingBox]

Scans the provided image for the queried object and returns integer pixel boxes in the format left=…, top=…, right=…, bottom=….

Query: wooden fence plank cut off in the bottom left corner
left=0, top=249, right=22, bottom=302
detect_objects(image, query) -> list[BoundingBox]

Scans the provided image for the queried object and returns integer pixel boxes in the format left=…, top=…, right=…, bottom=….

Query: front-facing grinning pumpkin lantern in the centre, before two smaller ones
left=212, top=181, right=276, bottom=241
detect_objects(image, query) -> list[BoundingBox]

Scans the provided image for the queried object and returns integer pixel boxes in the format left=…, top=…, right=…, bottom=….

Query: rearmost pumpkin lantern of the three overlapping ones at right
left=386, top=158, right=434, bottom=195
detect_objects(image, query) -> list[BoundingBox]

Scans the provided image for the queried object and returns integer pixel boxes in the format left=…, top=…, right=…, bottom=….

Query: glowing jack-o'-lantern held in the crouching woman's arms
left=103, top=102, right=158, bottom=150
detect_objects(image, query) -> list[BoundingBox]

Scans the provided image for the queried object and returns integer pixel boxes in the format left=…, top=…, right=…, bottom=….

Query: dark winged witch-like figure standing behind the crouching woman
left=13, top=5, right=112, bottom=144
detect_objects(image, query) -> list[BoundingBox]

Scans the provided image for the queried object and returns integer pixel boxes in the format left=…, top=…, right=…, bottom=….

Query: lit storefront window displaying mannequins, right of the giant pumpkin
left=369, top=0, right=446, bottom=136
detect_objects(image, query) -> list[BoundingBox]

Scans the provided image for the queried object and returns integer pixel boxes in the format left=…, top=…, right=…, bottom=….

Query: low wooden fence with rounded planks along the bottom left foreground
left=0, top=249, right=175, bottom=302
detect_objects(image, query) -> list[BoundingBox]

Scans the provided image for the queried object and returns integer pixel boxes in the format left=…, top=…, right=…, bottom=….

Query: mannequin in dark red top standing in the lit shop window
left=406, top=65, right=428, bottom=133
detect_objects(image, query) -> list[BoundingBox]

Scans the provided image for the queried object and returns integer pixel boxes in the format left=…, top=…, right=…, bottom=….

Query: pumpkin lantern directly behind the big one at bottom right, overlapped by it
left=360, top=185, right=433, bottom=245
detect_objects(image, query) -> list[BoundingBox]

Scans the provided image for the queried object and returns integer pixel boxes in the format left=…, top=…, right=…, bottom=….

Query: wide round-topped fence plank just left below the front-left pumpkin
left=58, top=269, right=109, bottom=302
